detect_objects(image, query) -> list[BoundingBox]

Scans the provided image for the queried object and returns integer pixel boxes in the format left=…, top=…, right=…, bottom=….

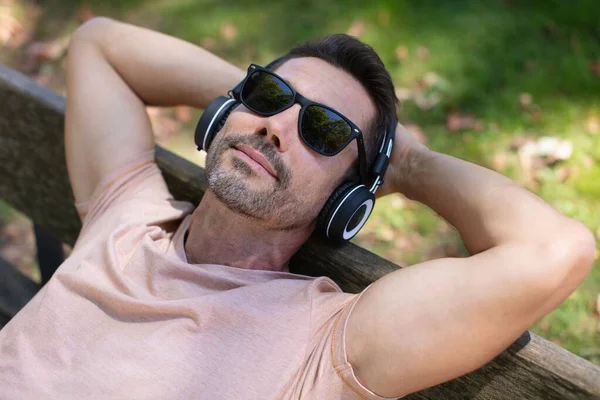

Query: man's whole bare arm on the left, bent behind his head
left=65, top=18, right=244, bottom=202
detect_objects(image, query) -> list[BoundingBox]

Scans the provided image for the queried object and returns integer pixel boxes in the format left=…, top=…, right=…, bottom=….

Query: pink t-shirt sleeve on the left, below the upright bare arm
left=73, top=149, right=193, bottom=250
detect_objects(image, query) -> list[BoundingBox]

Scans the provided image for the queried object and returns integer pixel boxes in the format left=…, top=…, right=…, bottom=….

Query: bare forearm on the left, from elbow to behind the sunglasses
left=75, top=18, right=244, bottom=108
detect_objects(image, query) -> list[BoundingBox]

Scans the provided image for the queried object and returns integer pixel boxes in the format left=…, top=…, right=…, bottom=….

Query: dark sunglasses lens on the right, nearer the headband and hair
left=301, top=105, right=352, bottom=155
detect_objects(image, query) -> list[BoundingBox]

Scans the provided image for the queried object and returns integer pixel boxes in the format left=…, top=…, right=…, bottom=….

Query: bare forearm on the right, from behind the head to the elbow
left=395, top=147, right=578, bottom=254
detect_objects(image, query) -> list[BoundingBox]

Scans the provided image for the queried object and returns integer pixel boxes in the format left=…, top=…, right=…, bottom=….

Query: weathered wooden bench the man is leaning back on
left=0, top=65, right=600, bottom=400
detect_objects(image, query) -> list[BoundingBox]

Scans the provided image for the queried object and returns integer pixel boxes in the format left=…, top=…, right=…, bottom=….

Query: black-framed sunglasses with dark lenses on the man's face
left=231, top=64, right=366, bottom=182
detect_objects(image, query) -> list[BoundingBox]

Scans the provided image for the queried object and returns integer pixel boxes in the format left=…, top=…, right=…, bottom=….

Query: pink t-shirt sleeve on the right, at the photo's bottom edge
left=302, top=282, right=398, bottom=400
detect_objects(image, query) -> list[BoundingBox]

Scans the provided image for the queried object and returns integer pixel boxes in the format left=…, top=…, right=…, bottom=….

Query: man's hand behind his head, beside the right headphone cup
left=376, top=124, right=428, bottom=198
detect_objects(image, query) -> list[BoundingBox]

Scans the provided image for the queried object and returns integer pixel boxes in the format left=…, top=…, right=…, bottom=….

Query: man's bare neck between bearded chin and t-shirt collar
left=185, top=190, right=313, bottom=272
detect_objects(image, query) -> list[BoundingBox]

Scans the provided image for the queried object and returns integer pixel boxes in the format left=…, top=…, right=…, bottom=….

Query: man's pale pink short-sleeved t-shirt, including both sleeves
left=0, top=151, right=398, bottom=400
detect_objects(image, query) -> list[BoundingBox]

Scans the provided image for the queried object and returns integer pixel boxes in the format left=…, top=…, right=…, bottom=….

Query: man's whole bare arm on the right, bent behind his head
left=346, top=127, right=595, bottom=397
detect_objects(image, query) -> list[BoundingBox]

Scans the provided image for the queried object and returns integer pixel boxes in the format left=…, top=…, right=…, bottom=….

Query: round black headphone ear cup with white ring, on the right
left=317, top=182, right=375, bottom=244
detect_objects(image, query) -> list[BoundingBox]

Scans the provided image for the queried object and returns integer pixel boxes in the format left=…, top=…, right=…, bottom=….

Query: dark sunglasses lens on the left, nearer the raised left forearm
left=241, top=71, right=294, bottom=114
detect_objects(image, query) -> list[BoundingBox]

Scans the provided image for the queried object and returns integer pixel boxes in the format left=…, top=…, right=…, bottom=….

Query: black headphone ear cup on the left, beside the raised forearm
left=194, top=96, right=238, bottom=151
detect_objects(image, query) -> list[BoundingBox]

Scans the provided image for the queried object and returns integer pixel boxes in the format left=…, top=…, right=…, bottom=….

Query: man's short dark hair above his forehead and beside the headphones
left=269, top=33, right=398, bottom=175
